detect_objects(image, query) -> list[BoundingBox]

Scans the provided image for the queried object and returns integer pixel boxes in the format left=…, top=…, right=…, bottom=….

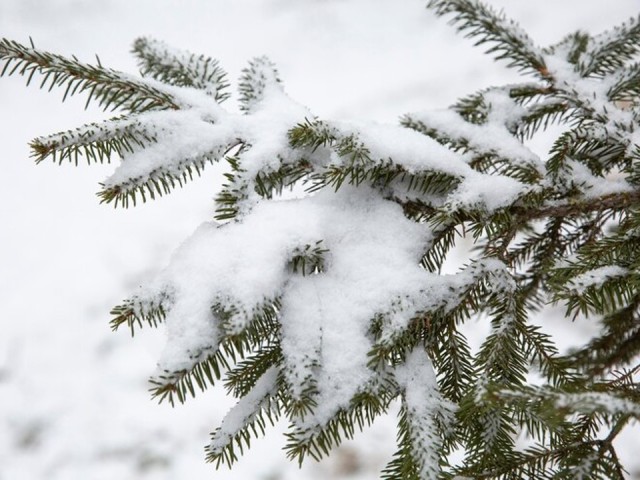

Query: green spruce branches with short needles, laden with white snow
left=0, top=0, right=640, bottom=479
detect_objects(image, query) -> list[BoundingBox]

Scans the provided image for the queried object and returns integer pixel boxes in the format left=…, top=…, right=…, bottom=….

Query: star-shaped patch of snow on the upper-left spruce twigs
left=103, top=70, right=311, bottom=208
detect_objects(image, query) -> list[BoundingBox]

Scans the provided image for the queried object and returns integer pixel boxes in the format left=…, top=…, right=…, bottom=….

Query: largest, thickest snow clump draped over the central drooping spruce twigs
left=142, top=187, right=432, bottom=423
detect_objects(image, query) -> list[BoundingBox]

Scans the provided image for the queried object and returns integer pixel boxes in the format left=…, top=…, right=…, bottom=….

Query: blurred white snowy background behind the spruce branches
left=0, top=0, right=640, bottom=480
